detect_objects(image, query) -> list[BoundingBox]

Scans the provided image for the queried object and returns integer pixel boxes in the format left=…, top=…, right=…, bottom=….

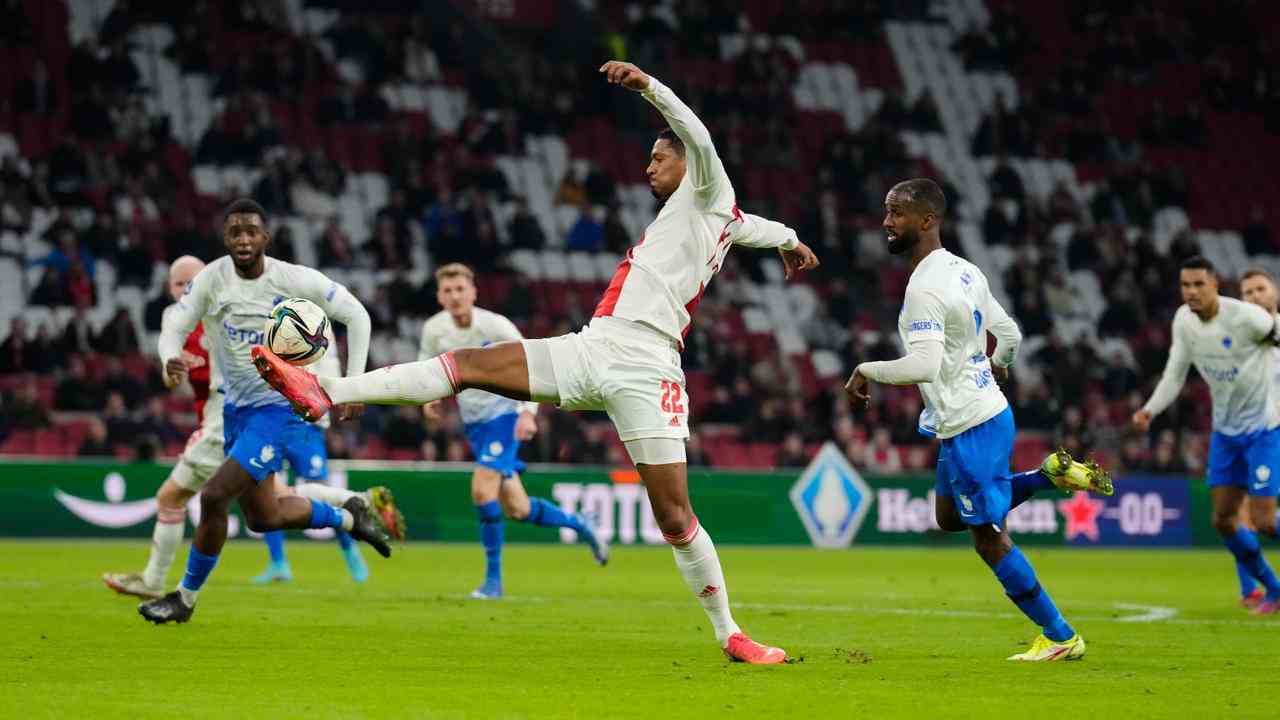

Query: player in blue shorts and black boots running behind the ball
left=138, top=200, right=390, bottom=624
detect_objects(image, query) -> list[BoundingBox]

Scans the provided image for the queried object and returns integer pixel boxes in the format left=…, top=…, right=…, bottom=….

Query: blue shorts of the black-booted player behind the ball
left=223, top=405, right=329, bottom=483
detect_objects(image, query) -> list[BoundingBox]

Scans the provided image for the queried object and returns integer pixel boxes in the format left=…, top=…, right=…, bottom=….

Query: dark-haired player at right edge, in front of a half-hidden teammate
left=1133, top=256, right=1280, bottom=615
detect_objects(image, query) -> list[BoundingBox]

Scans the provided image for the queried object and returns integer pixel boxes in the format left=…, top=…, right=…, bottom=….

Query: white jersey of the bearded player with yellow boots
left=861, top=249, right=1021, bottom=439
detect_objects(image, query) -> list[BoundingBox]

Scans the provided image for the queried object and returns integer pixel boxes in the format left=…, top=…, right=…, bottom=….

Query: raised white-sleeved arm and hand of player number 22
left=600, top=60, right=731, bottom=197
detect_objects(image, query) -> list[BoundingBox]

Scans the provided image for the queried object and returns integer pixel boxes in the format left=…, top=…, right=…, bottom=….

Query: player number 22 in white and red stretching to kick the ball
left=253, top=61, right=818, bottom=664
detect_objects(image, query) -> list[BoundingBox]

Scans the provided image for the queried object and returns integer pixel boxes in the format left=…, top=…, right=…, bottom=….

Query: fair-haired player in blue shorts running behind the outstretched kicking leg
left=419, top=263, right=609, bottom=600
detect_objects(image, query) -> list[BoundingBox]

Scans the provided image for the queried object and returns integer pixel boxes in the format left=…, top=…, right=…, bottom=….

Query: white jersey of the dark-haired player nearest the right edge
left=1143, top=297, right=1280, bottom=436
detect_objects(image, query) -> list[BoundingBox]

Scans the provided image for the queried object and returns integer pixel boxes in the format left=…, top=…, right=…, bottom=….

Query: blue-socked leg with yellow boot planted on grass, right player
left=970, top=524, right=1084, bottom=661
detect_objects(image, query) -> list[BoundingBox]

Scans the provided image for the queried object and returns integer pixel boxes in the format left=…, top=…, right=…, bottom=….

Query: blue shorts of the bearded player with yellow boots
left=933, top=407, right=1016, bottom=528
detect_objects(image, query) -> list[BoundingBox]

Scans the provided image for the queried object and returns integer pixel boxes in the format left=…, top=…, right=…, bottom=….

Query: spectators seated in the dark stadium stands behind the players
left=0, top=0, right=1280, bottom=471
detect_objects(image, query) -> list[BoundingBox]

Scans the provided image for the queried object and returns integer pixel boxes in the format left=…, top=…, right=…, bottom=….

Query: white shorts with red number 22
left=524, top=318, right=689, bottom=442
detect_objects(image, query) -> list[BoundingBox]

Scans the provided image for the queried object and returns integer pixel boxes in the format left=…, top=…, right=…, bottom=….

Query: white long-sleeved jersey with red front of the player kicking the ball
left=594, top=76, right=799, bottom=342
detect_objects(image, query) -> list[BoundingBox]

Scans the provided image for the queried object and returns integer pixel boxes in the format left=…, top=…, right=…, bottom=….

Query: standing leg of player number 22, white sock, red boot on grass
left=636, top=462, right=787, bottom=665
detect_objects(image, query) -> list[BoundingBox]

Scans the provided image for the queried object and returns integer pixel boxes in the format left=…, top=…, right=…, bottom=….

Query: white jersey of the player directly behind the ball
left=159, top=256, right=370, bottom=407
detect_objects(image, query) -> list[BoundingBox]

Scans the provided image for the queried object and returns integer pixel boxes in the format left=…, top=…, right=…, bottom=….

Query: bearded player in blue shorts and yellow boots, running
left=845, top=179, right=1112, bottom=661
